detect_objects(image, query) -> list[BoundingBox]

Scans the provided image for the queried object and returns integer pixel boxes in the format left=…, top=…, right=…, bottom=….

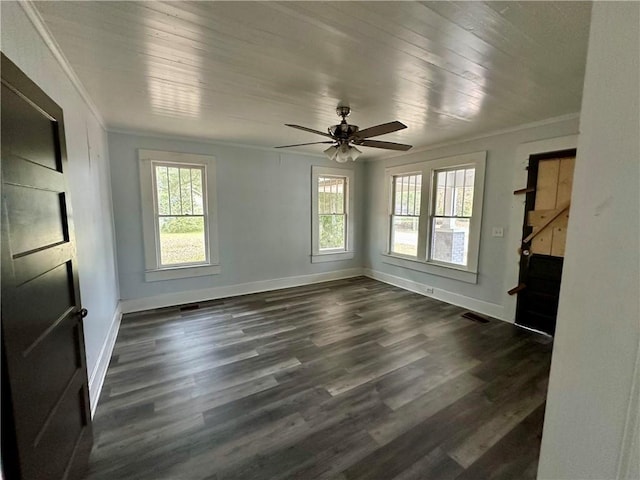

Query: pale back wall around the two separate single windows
left=109, top=133, right=364, bottom=311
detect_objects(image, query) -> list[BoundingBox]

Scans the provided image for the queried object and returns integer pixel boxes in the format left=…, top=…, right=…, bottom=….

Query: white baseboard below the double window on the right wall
left=364, top=268, right=513, bottom=323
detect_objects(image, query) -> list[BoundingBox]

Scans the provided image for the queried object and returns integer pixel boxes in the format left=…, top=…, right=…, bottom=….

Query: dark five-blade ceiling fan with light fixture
left=276, top=106, right=412, bottom=163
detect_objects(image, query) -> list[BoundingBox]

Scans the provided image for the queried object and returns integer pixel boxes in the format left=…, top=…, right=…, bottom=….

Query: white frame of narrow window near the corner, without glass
left=311, top=165, right=355, bottom=263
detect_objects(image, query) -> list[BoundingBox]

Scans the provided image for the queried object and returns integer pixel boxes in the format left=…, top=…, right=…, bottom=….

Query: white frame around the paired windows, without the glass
left=383, top=151, right=487, bottom=283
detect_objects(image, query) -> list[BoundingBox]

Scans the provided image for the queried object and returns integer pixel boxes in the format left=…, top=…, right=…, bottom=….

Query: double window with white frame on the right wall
left=385, top=152, right=486, bottom=283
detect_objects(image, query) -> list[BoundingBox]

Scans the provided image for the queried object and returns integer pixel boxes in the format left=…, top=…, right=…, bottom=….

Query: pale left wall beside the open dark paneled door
left=0, top=2, right=119, bottom=407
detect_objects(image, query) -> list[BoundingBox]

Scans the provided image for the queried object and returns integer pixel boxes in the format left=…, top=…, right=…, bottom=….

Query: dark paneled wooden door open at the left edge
left=1, top=55, right=92, bottom=480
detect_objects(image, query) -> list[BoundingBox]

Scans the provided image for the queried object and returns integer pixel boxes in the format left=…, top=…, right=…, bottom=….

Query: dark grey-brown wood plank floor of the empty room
left=88, top=278, right=551, bottom=480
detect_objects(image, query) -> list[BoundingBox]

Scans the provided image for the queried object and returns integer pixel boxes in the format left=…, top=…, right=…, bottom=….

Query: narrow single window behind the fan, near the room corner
left=311, top=166, right=353, bottom=263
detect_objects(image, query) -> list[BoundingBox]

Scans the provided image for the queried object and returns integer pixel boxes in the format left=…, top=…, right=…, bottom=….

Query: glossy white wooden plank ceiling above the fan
left=35, top=1, right=591, bottom=158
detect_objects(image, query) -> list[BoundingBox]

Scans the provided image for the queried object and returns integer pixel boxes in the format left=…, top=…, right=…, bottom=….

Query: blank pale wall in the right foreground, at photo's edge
left=538, top=2, right=640, bottom=480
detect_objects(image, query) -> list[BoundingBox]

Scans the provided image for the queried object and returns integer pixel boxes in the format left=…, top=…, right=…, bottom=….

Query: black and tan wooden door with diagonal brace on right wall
left=516, top=150, right=576, bottom=335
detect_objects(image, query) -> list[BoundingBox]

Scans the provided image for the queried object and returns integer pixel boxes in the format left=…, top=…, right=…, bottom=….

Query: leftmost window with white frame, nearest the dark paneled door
left=139, top=150, right=220, bottom=281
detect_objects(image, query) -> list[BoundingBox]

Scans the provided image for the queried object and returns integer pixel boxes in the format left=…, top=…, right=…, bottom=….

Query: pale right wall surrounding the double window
left=364, top=118, right=578, bottom=321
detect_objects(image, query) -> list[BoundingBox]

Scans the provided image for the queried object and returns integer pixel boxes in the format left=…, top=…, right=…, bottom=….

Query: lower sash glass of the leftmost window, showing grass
left=158, top=216, right=207, bottom=265
